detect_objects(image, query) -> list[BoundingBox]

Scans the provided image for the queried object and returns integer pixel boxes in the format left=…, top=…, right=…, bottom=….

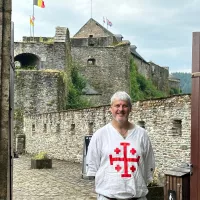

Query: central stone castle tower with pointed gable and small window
left=71, top=18, right=130, bottom=105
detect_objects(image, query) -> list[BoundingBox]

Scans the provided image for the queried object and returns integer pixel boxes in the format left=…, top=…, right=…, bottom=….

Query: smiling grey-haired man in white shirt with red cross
left=87, top=91, right=155, bottom=200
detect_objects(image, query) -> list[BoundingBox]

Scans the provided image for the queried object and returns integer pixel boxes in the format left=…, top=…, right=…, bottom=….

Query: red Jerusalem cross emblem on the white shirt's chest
left=109, top=142, right=140, bottom=177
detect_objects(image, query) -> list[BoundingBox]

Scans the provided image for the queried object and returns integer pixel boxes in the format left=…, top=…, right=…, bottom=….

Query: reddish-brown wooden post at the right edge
left=190, top=32, right=200, bottom=200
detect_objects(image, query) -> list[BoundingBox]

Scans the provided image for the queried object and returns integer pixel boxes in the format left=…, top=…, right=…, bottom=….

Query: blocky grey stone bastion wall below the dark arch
left=14, top=70, right=64, bottom=135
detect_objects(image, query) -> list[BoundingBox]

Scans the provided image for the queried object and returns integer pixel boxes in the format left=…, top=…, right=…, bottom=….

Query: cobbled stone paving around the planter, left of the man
left=13, top=155, right=96, bottom=200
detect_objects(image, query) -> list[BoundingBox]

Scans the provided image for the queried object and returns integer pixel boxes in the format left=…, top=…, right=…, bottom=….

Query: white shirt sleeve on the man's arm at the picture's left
left=86, top=133, right=101, bottom=176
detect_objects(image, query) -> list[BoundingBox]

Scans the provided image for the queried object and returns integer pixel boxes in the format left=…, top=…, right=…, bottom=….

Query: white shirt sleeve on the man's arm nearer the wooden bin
left=144, top=132, right=155, bottom=185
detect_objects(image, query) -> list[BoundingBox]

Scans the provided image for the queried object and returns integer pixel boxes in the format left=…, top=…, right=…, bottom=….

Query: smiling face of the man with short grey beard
left=110, top=99, right=131, bottom=123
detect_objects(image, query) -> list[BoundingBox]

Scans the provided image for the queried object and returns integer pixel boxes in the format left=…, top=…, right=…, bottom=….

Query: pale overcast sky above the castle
left=12, top=0, right=200, bottom=72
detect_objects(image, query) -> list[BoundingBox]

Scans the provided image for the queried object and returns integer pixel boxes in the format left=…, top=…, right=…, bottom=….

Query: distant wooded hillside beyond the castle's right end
left=171, top=72, right=192, bottom=94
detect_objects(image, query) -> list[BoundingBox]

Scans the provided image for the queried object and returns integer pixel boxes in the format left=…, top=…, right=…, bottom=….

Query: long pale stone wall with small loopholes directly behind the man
left=24, top=95, right=191, bottom=172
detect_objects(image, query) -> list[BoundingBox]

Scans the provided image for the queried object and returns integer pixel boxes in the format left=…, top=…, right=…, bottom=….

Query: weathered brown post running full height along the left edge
left=0, top=0, right=12, bottom=200
